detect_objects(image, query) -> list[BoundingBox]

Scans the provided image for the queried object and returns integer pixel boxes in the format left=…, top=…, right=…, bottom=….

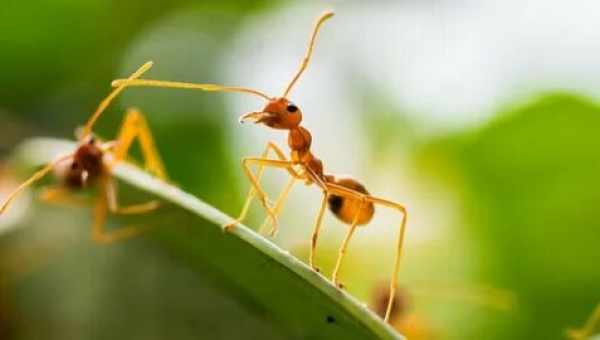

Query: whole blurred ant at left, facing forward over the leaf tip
left=0, top=62, right=166, bottom=243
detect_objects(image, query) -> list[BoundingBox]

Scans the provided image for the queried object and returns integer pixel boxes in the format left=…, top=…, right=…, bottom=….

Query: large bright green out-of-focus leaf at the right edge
left=423, top=94, right=600, bottom=339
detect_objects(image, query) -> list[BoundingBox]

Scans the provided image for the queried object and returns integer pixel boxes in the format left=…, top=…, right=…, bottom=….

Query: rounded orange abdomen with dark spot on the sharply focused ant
left=327, top=178, right=375, bottom=225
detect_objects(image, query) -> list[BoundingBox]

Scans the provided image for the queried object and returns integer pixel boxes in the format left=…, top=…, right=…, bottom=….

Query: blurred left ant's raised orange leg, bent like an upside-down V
left=113, top=108, right=167, bottom=179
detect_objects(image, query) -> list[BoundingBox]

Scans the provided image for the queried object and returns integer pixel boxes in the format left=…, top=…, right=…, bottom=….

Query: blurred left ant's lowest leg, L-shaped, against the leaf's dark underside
left=92, top=178, right=154, bottom=244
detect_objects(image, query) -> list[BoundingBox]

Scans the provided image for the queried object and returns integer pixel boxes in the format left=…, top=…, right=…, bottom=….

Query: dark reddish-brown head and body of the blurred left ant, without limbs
left=54, top=139, right=104, bottom=189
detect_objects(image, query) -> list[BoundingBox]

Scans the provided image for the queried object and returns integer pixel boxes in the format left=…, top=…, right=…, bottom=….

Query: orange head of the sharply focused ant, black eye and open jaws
left=240, top=97, right=302, bottom=130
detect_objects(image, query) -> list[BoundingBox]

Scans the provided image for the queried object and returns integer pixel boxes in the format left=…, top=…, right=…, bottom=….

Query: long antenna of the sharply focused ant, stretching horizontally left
left=112, top=77, right=273, bottom=100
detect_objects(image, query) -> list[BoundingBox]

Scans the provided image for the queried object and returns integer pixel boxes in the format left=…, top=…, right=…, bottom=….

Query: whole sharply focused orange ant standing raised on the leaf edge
left=113, top=12, right=407, bottom=321
